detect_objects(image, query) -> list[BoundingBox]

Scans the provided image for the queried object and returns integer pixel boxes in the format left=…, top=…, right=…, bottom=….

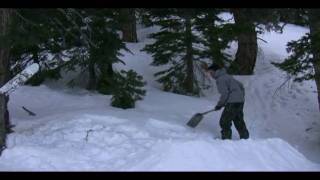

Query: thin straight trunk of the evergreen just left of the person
left=184, top=15, right=195, bottom=94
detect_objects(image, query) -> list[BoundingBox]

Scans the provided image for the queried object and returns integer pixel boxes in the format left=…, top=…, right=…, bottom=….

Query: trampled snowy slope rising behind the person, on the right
left=250, top=25, right=320, bottom=163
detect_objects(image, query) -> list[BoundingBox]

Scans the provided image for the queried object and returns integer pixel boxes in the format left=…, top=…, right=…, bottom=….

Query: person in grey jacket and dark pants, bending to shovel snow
left=204, top=63, right=249, bottom=139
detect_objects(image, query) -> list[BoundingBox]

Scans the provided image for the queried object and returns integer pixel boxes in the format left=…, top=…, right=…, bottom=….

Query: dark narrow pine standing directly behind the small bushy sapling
left=80, top=10, right=128, bottom=94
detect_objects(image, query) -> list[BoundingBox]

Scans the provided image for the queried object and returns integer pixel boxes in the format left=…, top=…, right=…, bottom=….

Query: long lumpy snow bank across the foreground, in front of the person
left=0, top=108, right=320, bottom=171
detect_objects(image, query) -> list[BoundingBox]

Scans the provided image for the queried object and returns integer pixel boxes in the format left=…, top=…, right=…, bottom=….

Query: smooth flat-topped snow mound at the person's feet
left=134, top=139, right=319, bottom=171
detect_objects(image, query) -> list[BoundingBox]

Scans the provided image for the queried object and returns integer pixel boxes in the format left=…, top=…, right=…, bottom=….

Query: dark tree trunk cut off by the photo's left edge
left=0, top=9, right=11, bottom=153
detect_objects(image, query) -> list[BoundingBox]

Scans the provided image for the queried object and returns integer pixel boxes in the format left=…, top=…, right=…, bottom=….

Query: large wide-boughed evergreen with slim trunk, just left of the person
left=143, top=9, right=227, bottom=95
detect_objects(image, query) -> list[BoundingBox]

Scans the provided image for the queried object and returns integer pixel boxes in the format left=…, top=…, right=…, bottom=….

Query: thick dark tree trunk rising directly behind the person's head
left=230, top=9, right=258, bottom=75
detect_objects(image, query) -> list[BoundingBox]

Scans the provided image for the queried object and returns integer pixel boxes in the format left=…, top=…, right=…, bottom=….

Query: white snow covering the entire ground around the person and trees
left=0, top=21, right=320, bottom=171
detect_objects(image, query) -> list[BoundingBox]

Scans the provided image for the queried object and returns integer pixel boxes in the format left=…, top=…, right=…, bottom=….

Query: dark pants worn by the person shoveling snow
left=220, top=103, right=249, bottom=139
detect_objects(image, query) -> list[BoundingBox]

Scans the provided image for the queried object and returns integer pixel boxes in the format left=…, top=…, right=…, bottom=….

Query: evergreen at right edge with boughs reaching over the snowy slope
left=273, top=9, right=320, bottom=110
